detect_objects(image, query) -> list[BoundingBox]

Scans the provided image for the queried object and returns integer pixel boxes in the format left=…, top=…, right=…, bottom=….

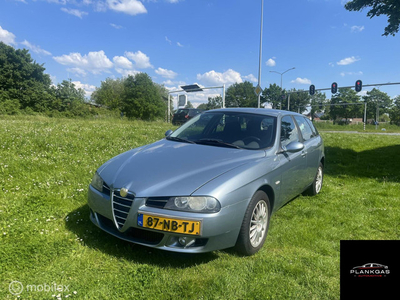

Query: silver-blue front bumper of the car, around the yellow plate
left=88, top=186, right=249, bottom=253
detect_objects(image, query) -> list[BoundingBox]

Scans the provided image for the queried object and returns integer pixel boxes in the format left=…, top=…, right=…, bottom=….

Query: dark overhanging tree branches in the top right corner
left=344, top=0, right=400, bottom=36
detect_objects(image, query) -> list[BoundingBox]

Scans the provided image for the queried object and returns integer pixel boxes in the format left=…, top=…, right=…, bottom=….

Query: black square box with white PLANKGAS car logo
left=340, top=240, right=400, bottom=300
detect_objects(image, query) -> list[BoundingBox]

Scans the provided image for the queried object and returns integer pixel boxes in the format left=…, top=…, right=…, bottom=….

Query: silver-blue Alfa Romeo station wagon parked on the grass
left=88, top=108, right=325, bottom=255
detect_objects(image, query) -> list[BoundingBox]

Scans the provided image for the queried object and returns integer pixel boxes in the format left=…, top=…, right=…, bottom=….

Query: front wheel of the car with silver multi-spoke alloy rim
left=235, top=191, right=271, bottom=256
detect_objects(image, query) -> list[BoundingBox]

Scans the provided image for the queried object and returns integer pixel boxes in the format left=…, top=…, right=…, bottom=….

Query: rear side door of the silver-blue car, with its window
left=294, top=116, right=322, bottom=185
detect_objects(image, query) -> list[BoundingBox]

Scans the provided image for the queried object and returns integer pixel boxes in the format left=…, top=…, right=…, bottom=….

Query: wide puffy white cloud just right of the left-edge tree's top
left=53, top=50, right=114, bottom=74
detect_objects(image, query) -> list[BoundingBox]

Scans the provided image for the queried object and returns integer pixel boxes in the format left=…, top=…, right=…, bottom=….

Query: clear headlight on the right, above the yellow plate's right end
left=164, top=197, right=221, bottom=213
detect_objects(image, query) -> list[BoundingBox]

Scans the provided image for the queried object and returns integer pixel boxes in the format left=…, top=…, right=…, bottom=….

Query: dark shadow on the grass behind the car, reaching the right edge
left=325, top=145, right=400, bottom=182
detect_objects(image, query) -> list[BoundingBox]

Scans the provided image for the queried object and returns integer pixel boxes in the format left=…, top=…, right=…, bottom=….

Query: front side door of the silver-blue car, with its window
left=279, top=115, right=308, bottom=205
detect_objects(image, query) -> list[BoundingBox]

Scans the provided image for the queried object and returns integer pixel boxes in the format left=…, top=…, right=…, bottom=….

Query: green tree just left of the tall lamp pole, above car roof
left=225, top=81, right=258, bottom=107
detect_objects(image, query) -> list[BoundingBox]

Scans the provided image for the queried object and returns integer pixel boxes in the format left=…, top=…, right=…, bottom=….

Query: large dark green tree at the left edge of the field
left=0, top=42, right=55, bottom=111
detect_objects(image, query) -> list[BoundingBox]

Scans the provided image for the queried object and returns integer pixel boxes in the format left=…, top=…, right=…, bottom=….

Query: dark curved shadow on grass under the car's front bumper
left=65, top=204, right=219, bottom=269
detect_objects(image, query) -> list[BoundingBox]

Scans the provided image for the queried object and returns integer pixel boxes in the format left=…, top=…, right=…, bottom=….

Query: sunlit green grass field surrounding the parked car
left=0, top=116, right=400, bottom=299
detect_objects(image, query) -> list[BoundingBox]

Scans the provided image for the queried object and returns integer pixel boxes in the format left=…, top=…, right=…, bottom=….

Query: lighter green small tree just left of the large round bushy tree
left=91, top=78, right=124, bottom=110
